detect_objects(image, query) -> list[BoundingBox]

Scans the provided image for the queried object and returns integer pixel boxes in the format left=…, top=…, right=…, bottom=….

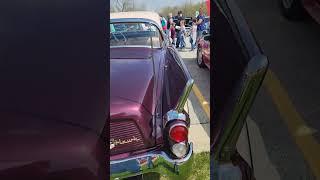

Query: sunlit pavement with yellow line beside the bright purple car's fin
left=179, top=39, right=210, bottom=153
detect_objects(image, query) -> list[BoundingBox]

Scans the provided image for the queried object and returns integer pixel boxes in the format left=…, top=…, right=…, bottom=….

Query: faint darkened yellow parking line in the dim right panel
left=264, top=70, right=320, bottom=179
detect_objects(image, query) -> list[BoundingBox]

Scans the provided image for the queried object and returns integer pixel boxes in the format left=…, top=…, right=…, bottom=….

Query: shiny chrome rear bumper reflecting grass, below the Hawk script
left=110, top=142, right=193, bottom=179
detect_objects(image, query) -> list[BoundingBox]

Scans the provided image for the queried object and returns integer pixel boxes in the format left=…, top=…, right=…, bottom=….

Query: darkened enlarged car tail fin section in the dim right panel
left=210, top=0, right=268, bottom=179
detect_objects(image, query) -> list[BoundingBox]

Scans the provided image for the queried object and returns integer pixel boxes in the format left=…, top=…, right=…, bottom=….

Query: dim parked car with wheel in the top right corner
left=280, top=0, right=320, bottom=24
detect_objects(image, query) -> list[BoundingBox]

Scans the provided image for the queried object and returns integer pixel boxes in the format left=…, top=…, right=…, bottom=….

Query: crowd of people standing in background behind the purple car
left=160, top=8, right=206, bottom=51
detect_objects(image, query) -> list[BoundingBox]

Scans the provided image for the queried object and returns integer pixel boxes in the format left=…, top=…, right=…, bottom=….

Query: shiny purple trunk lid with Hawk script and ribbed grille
left=110, top=48, right=162, bottom=155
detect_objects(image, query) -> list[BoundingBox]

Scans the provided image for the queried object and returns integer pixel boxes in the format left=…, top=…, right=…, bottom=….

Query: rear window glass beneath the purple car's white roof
left=110, top=23, right=163, bottom=48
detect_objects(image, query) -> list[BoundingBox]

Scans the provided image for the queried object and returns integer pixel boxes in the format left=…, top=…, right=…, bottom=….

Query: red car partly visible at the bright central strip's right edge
left=196, top=31, right=210, bottom=69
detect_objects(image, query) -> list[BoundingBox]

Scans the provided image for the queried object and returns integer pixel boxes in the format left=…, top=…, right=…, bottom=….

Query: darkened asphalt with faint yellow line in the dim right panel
left=235, top=0, right=320, bottom=180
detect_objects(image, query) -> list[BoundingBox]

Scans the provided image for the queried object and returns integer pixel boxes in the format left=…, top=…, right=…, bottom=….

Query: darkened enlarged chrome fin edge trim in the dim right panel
left=211, top=55, right=269, bottom=162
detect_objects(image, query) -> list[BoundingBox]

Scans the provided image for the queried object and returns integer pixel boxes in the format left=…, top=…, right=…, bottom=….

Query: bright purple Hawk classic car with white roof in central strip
left=110, top=12, right=193, bottom=179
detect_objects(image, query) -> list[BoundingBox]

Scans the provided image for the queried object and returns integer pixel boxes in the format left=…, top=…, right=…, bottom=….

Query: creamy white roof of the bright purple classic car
left=110, top=11, right=162, bottom=27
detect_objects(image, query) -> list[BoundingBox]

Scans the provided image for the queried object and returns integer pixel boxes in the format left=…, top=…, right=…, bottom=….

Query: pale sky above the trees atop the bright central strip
left=111, top=0, right=205, bottom=11
